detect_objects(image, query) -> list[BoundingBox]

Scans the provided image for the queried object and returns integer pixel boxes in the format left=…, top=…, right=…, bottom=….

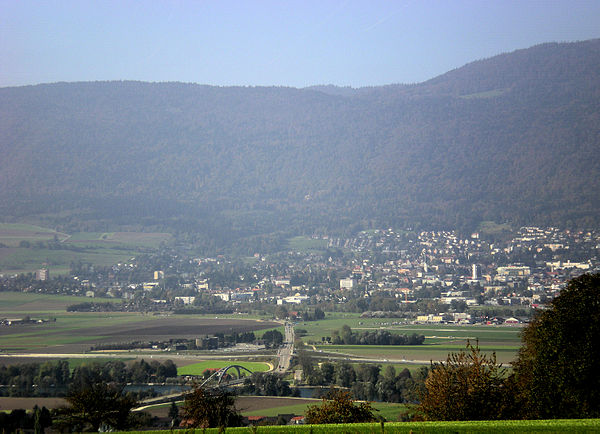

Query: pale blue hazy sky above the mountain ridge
left=0, top=0, right=600, bottom=87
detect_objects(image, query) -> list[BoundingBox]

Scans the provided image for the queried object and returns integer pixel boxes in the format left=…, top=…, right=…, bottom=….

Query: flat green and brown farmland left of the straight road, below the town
left=0, top=292, right=281, bottom=355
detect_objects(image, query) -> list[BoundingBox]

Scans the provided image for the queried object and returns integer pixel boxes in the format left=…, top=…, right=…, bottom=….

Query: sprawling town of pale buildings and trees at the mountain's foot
left=5, top=227, right=600, bottom=322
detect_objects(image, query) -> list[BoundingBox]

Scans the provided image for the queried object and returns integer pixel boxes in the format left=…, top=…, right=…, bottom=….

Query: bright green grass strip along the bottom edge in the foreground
left=131, top=419, right=600, bottom=434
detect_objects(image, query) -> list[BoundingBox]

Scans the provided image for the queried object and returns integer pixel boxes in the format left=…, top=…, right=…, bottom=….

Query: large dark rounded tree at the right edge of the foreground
left=514, top=274, right=600, bottom=418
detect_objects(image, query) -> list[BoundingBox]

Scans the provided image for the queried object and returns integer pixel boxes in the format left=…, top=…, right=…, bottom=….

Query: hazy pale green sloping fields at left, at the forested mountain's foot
left=0, top=223, right=171, bottom=275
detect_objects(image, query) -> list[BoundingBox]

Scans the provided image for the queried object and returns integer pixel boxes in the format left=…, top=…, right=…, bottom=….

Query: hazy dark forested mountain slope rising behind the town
left=0, top=40, right=600, bottom=251
